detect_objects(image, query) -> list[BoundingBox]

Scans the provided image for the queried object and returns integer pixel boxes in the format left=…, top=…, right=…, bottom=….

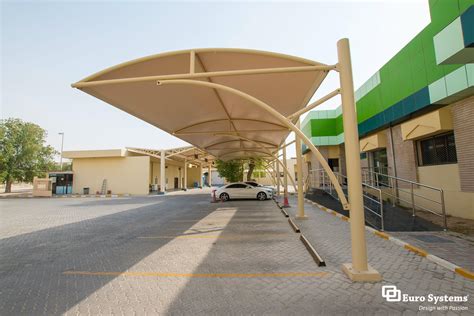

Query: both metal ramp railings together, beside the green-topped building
left=306, top=169, right=448, bottom=231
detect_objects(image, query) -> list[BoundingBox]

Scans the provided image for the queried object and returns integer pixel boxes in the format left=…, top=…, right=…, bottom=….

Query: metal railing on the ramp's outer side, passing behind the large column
left=309, top=169, right=385, bottom=231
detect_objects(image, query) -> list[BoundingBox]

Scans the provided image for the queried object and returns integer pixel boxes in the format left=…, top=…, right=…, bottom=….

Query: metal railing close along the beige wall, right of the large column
left=362, top=168, right=448, bottom=230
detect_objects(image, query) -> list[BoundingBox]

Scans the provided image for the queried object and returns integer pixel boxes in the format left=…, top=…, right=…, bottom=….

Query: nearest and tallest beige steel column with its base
left=337, top=38, right=381, bottom=281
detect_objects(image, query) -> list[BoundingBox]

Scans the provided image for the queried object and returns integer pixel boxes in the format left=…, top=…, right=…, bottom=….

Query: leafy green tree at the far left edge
left=0, top=118, right=57, bottom=193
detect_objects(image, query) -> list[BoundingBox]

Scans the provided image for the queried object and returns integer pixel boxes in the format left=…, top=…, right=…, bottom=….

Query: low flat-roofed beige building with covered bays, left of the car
left=63, top=147, right=212, bottom=195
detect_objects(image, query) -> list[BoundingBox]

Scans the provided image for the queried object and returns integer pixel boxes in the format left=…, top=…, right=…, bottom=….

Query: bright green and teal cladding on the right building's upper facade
left=303, top=0, right=474, bottom=141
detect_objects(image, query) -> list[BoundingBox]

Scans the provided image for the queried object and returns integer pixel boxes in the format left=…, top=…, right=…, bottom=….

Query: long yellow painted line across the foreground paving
left=63, top=271, right=329, bottom=278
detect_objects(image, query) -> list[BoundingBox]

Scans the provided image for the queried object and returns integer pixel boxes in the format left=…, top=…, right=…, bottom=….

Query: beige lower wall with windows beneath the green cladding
left=305, top=96, right=474, bottom=219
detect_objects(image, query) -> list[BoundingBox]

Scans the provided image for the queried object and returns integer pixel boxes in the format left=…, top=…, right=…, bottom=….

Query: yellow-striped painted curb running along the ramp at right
left=305, top=199, right=474, bottom=280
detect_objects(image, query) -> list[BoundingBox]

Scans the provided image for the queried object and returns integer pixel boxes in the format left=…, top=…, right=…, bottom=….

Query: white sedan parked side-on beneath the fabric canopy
left=212, top=182, right=273, bottom=201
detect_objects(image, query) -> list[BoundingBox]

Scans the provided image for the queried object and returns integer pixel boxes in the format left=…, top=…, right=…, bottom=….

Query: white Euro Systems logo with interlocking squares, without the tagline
left=382, top=285, right=469, bottom=305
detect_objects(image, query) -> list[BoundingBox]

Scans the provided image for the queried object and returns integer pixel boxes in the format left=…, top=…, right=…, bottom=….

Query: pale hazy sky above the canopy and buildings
left=0, top=0, right=430, bottom=156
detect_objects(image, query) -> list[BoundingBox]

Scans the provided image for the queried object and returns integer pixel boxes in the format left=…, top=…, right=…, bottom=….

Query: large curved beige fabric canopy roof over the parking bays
left=73, top=49, right=327, bottom=159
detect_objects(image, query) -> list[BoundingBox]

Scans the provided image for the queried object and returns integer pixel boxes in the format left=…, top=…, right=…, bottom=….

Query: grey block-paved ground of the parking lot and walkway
left=0, top=190, right=474, bottom=315
